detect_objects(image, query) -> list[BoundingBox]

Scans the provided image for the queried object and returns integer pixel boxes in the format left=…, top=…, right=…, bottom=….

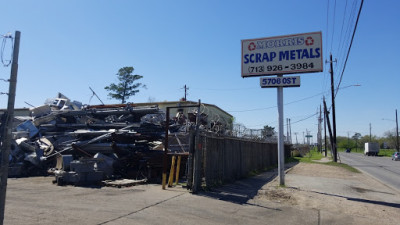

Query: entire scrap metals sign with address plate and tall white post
left=241, top=32, right=323, bottom=185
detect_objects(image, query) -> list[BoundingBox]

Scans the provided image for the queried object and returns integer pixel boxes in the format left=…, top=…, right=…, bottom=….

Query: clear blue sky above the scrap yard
left=0, top=0, right=400, bottom=140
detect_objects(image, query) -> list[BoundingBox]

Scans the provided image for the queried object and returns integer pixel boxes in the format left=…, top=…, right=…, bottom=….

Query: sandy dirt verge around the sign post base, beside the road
left=257, top=163, right=400, bottom=224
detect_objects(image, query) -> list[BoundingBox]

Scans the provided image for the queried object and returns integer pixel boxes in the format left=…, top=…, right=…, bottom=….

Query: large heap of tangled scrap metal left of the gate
left=9, top=94, right=198, bottom=185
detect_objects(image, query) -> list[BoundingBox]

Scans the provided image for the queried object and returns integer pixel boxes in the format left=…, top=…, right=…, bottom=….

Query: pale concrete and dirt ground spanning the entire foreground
left=4, top=163, right=400, bottom=225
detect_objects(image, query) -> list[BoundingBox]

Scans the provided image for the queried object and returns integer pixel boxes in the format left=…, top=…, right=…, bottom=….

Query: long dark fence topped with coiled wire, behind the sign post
left=194, top=134, right=290, bottom=189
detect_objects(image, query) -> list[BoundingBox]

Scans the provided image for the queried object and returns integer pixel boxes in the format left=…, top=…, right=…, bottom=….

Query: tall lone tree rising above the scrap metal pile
left=104, top=67, right=146, bottom=104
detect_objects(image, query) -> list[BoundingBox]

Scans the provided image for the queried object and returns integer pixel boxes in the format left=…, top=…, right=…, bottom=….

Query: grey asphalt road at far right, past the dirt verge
left=339, top=152, right=400, bottom=191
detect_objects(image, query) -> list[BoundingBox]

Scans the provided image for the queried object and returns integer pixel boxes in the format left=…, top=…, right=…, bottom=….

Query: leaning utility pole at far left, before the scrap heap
left=0, top=31, right=21, bottom=225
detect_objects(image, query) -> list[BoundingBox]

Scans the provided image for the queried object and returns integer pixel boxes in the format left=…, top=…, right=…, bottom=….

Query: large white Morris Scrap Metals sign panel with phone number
left=242, top=32, right=323, bottom=77
